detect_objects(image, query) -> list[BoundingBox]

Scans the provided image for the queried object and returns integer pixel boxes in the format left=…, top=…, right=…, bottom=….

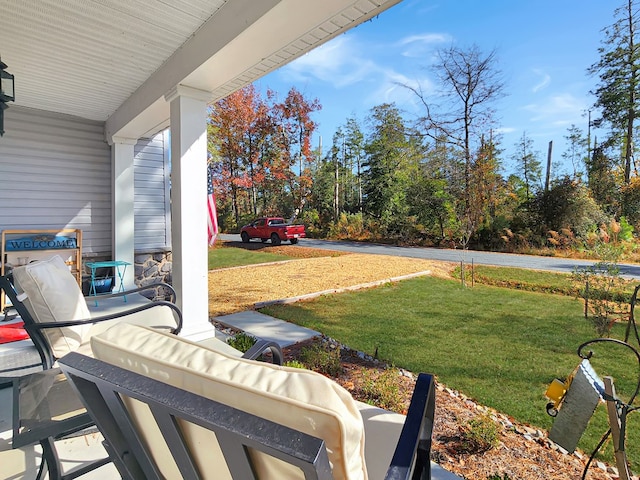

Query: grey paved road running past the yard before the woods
left=220, top=234, right=640, bottom=280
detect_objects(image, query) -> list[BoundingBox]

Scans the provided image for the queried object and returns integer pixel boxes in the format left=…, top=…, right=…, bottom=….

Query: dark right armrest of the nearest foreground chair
left=385, top=373, right=436, bottom=480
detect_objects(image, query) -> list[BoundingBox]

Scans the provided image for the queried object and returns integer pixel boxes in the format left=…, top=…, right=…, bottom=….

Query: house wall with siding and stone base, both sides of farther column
left=0, top=105, right=171, bottom=284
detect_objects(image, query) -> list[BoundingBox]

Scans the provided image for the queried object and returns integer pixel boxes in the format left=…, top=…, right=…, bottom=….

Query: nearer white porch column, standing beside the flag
left=165, top=85, right=213, bottom=340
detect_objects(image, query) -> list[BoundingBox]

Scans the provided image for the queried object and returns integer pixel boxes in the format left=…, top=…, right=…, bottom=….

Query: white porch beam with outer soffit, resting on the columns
left=105, top=0, right=400, bottom=143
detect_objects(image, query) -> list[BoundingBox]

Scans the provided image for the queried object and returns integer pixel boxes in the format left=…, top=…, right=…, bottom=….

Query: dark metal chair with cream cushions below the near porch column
left=0, top=257, right=282, bottom=369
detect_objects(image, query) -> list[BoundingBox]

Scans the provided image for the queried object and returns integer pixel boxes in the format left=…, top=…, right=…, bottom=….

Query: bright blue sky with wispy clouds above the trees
left=256, top=0, right=620, bottom=173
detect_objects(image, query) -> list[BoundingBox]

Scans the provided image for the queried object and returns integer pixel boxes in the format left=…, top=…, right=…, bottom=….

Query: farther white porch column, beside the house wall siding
left=111, top=137, right=137, bottom=291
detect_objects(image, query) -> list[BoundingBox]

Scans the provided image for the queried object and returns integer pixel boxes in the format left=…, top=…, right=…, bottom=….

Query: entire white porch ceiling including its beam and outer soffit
left=0, top=0, right=400, bottom=138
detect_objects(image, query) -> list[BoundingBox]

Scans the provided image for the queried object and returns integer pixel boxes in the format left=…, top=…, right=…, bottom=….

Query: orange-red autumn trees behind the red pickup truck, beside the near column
left=208, top=85, right=320, bottom=228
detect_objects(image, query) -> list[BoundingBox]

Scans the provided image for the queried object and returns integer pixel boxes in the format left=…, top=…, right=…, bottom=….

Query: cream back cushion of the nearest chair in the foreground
left=91, top=323, right=368, bottom=479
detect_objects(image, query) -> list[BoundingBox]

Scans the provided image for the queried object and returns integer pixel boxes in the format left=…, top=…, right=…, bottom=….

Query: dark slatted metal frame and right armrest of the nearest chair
left=59, top=353, right=435, bottom=480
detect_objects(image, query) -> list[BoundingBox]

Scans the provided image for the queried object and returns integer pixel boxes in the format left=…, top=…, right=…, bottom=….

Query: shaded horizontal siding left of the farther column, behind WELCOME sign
left=0, top=104, right=111, bottom=254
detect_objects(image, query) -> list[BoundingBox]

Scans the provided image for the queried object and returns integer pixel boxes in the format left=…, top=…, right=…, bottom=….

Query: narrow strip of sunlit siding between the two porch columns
left=134, top=131, right=171, bottom=252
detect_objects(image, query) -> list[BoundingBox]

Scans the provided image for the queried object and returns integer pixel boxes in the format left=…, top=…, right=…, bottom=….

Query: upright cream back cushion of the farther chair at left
left=13, top=255, right=91, bottom=358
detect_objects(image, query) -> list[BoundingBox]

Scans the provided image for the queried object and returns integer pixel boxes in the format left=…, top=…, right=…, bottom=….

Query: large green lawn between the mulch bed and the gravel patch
left=261, top=273, right=640, bottom=471
